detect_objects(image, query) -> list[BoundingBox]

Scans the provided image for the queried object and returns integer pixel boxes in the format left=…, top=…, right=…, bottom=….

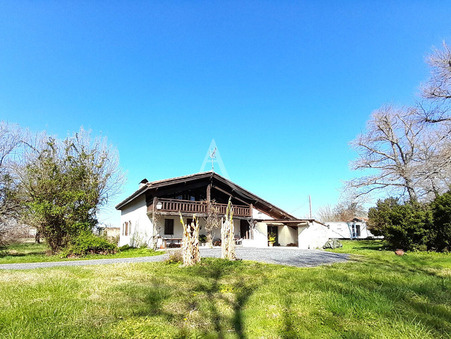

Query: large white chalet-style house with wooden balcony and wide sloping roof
left=116, top=171, right=328, bottom=249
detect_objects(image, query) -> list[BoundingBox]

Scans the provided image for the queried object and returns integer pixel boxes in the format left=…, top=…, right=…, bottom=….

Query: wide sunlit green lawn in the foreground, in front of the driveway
left=0, top=242, right=451, bottom=338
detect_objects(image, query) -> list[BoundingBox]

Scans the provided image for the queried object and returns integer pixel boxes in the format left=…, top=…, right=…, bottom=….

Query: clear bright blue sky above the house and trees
left=0, top=0, right=451, bottom=225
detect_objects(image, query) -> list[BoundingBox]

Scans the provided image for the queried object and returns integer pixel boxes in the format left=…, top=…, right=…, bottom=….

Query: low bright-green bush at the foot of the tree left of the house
left=63, top=232, right=117, bottom=256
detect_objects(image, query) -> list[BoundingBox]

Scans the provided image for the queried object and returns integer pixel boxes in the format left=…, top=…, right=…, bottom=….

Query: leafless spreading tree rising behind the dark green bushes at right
left=347, top=106, right=450, bottom=201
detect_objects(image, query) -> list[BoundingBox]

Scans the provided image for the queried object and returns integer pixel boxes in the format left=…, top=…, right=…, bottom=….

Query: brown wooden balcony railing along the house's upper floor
left=147, top=198, right=252, bottom=217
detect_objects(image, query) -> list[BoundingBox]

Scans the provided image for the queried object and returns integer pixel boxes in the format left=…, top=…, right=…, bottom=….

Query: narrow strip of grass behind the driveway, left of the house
left=0, top=243, right=162, bottom=264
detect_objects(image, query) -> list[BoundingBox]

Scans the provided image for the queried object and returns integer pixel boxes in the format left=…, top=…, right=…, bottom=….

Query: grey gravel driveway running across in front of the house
left=0, top=247, right=349, bottom=270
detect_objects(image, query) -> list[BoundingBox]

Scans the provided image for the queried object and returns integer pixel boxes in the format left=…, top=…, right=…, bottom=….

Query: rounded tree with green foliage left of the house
left=16, top=128, right=123, bottom=252
